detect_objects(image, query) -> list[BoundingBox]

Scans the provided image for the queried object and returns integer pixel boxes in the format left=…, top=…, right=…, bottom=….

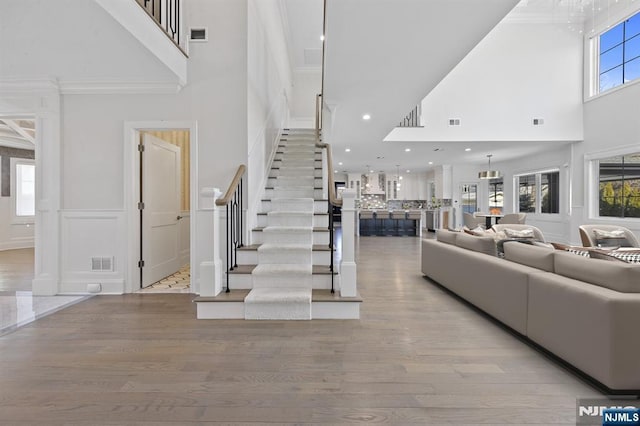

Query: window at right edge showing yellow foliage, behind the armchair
left=598, top=153, right=640, bottom=217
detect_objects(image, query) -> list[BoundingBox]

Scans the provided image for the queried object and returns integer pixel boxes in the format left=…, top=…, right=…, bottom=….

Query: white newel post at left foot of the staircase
left=200, top=188, right=222, bottom=297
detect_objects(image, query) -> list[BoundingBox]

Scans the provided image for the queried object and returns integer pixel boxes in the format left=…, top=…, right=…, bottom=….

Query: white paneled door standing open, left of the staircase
left=141, top=134, right=181, bottom=287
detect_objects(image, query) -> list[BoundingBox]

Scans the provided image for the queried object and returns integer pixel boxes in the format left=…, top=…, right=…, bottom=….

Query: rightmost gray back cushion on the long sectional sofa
left=554, top=251, right=640, bottom=293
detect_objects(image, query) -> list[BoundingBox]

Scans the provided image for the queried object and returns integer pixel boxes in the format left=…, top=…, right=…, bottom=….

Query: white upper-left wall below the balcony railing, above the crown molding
left=0, top=0, right=178, bottom=86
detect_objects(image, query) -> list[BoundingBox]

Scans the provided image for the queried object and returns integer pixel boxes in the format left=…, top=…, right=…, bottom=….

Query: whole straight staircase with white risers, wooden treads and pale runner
left=195, top=129, right=362, bottom=320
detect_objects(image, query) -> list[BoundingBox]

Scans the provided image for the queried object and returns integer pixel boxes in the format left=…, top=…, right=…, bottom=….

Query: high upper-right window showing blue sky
left=597, top=13, right=640, bottom=93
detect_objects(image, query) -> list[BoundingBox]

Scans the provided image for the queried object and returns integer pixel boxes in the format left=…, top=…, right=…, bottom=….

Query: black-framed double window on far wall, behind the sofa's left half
left=516, top=170, right=560, bottom=213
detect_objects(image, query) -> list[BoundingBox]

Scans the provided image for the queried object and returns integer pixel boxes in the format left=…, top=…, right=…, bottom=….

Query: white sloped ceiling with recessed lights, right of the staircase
left=323, top=0, right=517, bottom=171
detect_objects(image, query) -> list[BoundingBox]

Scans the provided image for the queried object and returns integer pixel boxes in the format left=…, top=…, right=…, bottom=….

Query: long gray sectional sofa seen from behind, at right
left=422, top=230, right=640, bottom=394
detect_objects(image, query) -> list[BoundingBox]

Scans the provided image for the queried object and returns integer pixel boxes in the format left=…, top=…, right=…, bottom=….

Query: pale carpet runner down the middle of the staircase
left=244, top=135, right=322, bottom=320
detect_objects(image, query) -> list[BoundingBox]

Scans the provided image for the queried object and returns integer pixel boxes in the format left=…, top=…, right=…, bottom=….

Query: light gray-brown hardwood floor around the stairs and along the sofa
left=0, top=237, right=601, bottom=425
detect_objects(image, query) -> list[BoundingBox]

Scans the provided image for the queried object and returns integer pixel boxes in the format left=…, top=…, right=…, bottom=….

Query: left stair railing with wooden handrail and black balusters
left=216, top=164, right=247, bottom=293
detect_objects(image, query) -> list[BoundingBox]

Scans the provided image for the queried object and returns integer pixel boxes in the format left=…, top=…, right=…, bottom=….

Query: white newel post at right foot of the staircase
left=340, top=189, right=358, bottom=297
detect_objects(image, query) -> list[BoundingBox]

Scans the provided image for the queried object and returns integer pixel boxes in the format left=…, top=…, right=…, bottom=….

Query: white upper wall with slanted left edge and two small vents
left=385, top=22, right=582, bottom=142
